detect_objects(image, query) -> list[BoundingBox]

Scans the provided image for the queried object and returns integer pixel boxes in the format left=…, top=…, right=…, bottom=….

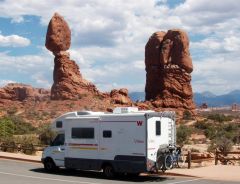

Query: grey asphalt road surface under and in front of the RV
left=0, top=159, right=239, bottom=184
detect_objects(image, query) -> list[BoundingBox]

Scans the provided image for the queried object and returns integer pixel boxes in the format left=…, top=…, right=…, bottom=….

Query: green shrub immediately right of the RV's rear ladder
left=177, top=125, right=192, bottom=146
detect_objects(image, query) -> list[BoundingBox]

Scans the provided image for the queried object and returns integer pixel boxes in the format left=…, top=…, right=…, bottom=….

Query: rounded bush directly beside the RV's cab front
left=37, top=124, right=56, bottom=145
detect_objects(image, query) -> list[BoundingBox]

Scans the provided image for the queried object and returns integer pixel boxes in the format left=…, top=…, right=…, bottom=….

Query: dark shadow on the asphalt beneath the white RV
left=30, top=168, right=174, bottom=182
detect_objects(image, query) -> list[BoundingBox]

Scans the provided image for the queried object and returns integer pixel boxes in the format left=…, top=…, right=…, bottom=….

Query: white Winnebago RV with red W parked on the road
left=42, top=107, right=176, bottom=177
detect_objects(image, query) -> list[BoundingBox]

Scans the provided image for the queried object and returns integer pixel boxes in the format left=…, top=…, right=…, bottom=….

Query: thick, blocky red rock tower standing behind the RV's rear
left=145, top=29, right=195, bottom=110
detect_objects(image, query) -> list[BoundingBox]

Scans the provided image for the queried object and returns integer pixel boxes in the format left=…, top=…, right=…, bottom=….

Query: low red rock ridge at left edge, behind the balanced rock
left=0, top=83, right=50, bottom=101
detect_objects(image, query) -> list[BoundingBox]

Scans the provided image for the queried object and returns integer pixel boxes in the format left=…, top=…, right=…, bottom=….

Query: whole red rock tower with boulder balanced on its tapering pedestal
left=45, top=13, right=100, bottom=100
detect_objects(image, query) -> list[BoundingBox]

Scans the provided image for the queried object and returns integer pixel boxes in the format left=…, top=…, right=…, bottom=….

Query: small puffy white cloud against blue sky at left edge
left=0, top=35, right=31, bottom=47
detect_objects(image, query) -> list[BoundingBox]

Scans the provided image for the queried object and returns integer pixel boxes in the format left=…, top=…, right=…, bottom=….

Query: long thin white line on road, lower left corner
left=0, top=172, right=101, bottom=184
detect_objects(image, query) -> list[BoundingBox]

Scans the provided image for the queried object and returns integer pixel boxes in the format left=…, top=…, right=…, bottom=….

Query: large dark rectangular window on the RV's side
left=72, top=128, right=94, bottom=139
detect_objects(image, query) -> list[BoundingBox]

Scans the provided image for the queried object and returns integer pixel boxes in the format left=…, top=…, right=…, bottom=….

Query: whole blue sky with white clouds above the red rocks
left=0, top=0, right=240, bottom=94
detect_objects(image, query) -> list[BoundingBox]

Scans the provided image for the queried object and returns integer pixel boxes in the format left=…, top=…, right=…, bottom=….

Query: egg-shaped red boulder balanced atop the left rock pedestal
left=45, top=13, right=71, bottom=53
